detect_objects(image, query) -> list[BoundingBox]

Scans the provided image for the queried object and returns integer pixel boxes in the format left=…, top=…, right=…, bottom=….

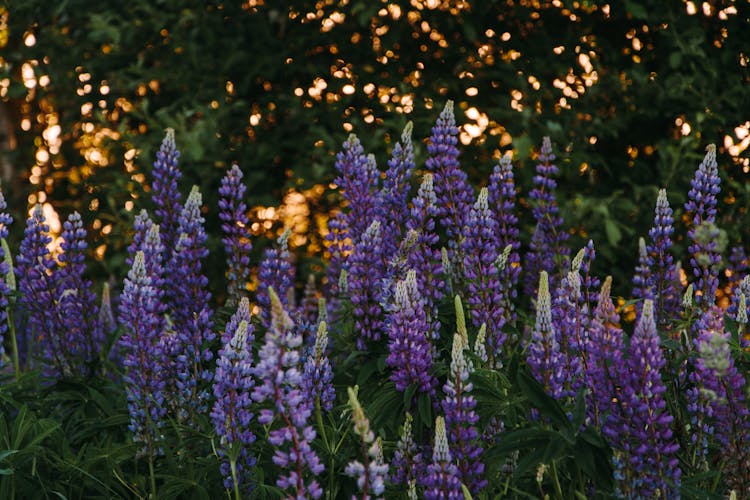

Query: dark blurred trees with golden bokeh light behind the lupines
left=0, top=0, right=750, bottom=293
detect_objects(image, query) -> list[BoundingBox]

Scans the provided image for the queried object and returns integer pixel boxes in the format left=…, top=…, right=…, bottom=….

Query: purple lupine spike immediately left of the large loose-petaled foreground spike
left=211, top=320, right=255, bottom=491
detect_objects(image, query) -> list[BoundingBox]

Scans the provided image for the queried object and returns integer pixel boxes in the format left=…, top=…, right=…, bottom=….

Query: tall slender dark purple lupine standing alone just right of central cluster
left=524, top=137, right=570, bottom=296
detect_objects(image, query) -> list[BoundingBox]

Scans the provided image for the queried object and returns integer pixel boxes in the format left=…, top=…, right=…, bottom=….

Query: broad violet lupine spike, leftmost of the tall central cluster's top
left=333, top=134, right=380, bottom=241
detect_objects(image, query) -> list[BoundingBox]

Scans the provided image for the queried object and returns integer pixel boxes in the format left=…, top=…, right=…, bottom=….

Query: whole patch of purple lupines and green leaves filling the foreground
left=0, top=101, right=750, bottom=499
